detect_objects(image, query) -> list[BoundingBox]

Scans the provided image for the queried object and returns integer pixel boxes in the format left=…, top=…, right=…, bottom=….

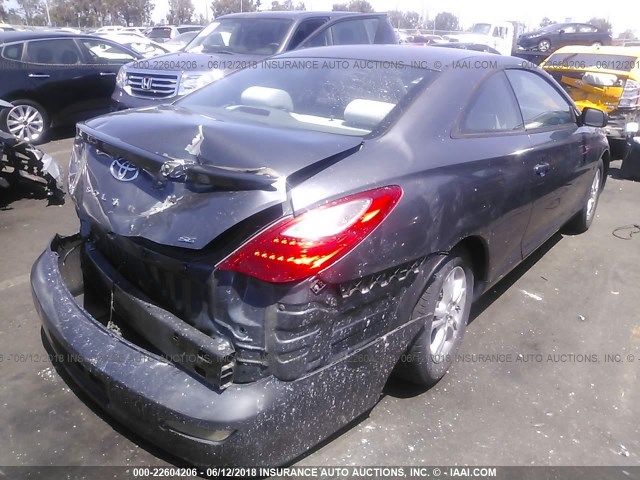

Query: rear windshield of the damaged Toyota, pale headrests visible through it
left=176, top=58, right=437, bottom=136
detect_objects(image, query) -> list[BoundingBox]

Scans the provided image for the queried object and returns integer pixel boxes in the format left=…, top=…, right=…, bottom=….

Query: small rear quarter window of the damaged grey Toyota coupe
left=460, top=72, right=522, bottom=133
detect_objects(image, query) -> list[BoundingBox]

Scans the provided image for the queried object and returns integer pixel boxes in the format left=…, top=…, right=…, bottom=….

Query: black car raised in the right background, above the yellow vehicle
left=518, top=23, right=611, bottom=52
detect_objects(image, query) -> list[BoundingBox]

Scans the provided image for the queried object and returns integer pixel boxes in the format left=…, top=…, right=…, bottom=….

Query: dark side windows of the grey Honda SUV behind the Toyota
left=298, top=14, right=397, bottom=48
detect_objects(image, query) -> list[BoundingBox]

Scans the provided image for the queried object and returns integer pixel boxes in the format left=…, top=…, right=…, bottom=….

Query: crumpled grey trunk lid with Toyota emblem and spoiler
left=69, top=105, right=362, bottom=249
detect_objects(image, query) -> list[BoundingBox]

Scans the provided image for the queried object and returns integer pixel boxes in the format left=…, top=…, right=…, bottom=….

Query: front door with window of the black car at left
left=78, top=38, right=139, bottom=110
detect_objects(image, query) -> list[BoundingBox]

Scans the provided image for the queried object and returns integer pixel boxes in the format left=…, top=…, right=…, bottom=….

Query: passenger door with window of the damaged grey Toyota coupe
left=506, top=69, right=588, bottom=256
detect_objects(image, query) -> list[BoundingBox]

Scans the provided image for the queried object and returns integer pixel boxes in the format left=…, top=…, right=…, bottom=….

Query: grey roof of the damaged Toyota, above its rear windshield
left=271, top=44, right=522, bottom=70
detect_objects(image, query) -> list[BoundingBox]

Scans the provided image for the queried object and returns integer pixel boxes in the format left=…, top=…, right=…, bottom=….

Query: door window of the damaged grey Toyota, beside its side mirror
left=506, top=70, right=575, bottom=130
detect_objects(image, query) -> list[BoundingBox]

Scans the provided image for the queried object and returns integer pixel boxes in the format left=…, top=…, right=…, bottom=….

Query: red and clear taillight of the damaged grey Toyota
left=217, top=185, right=402, bottom=283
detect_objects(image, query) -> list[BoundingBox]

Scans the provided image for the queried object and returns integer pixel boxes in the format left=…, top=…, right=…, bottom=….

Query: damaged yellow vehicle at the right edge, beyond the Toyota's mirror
left=541, top=46, right=640, bottom=176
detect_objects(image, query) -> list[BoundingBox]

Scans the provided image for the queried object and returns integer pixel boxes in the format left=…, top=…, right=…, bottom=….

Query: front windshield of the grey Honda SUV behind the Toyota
left=185, top=18, right=292, bottom=55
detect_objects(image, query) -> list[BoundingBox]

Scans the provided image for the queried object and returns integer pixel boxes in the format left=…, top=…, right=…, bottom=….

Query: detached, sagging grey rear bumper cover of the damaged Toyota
left=31, top=237, right=419, bottom=466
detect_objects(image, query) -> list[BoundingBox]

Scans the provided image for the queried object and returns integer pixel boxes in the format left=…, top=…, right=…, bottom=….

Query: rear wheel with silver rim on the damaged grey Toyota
left=394, top=251, right=474, bottom=387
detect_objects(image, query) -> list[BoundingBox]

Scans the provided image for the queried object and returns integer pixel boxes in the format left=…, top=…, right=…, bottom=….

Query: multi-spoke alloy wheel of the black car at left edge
left=0, top=99, right=49, bottom=143
